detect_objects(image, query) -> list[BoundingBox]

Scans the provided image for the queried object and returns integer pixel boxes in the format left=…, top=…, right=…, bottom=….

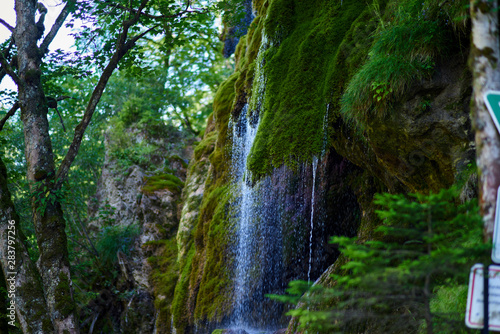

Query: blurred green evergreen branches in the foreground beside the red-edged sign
left=275, top=188, right=491, bottom=333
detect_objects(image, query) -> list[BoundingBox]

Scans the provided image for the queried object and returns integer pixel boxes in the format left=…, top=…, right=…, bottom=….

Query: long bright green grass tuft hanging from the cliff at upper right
left=340, top=0, right=466, bottom=128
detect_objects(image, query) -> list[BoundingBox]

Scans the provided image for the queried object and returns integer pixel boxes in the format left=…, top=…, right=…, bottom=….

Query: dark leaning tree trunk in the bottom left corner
left=0, top=159, right=54, bottom=333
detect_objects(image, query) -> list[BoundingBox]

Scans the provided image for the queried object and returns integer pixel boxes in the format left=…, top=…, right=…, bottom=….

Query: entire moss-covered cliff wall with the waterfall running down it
left=92, top=0, right=475, bottom=333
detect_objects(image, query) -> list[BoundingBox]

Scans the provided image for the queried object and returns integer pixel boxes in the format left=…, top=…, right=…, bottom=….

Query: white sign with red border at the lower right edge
left=465, top=264, right=500, bottom=330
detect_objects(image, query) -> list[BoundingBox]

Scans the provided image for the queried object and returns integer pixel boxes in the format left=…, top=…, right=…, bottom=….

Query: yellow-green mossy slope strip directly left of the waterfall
left=172, top=44, right=241, bottom=333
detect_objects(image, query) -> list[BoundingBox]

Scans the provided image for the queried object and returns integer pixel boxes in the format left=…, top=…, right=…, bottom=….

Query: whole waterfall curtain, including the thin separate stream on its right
left=227, top=23, right=340, bottom=333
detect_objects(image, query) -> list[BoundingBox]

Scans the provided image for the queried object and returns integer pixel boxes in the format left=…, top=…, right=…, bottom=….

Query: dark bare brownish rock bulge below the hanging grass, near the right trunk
left=358, top=54, right=475, bottom=192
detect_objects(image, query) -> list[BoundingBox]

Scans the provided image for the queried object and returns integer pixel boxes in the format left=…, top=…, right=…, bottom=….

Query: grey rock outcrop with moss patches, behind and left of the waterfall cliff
left=89, top=124, right=192, bottom=333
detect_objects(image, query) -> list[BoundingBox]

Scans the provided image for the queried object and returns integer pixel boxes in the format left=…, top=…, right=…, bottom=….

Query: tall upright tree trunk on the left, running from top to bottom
left=14, top=0, right=79, bottom=333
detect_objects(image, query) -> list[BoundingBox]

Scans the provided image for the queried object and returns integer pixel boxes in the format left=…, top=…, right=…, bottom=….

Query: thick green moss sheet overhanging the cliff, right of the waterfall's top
left=248, top=0, right=372, bottom=178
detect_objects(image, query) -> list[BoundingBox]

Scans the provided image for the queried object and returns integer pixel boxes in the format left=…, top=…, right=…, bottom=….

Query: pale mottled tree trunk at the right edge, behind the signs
left=470, top=0, right=500, bottom=239
